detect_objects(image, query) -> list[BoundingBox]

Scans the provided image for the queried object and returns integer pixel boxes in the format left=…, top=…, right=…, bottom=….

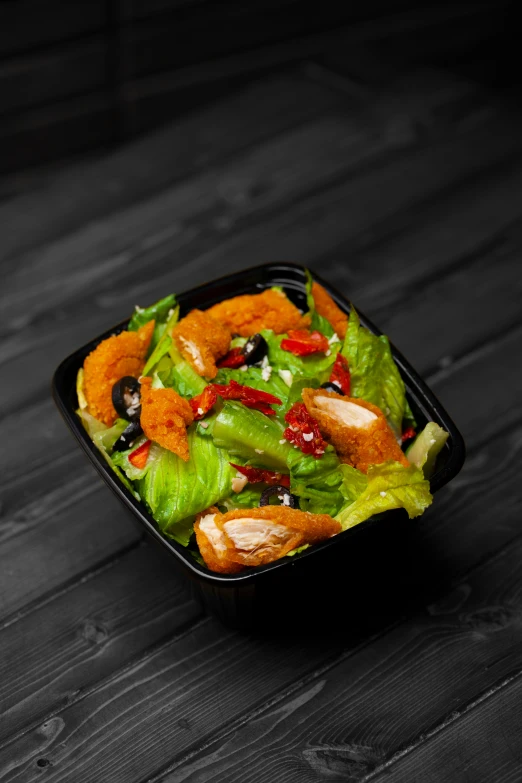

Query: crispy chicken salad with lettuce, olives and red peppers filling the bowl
left=77, top=272, right=448, bottom=574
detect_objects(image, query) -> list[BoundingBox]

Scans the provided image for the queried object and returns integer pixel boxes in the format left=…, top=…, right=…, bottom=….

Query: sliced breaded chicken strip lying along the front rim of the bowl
left=196, top=506, right=341, bottom=573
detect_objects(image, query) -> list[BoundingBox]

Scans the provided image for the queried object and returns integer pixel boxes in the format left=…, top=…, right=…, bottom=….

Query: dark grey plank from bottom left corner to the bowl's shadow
left=0, top=620, right=339, bottom=783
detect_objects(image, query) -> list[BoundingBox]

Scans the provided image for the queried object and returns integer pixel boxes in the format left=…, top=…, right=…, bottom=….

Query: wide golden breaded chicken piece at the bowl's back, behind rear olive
left=203, top=289, right=310, bottom=337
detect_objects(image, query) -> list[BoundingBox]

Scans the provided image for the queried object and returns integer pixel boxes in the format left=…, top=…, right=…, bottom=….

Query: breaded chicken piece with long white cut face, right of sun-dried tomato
left=303, top=389, right=410, bottom=473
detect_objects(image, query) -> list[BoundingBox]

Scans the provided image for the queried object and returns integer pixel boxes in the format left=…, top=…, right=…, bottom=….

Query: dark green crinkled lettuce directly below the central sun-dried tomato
left=287, top=446, right=344, bottom=516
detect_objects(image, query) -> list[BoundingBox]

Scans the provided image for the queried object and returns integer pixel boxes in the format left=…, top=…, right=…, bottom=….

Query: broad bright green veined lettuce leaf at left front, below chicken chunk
left=138, top=427, right=236, bottom=546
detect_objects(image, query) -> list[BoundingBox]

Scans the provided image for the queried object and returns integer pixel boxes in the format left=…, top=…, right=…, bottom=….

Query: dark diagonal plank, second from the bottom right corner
left=142, top=528, right=522, bottom=783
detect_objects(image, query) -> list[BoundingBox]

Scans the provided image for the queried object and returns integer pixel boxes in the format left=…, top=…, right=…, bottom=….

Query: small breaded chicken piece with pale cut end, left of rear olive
left=172, top=310, right=230, bottom=378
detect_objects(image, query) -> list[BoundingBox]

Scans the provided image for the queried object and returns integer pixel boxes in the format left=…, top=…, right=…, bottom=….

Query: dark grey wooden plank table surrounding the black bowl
left=0, top=56, right=522, bottom=783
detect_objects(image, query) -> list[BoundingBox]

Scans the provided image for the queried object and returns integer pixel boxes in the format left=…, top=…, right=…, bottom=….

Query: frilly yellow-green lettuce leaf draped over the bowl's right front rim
left=335, top=462, right=433, bottom=530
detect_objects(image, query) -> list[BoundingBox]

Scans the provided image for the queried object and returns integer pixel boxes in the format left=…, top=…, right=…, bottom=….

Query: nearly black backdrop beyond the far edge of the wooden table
left=0, top=0, right=519, bottom=173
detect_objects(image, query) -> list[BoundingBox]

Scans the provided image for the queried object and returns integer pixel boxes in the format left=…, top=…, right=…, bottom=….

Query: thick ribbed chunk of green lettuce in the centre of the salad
left=212, top=400, right=291, bottom=472
